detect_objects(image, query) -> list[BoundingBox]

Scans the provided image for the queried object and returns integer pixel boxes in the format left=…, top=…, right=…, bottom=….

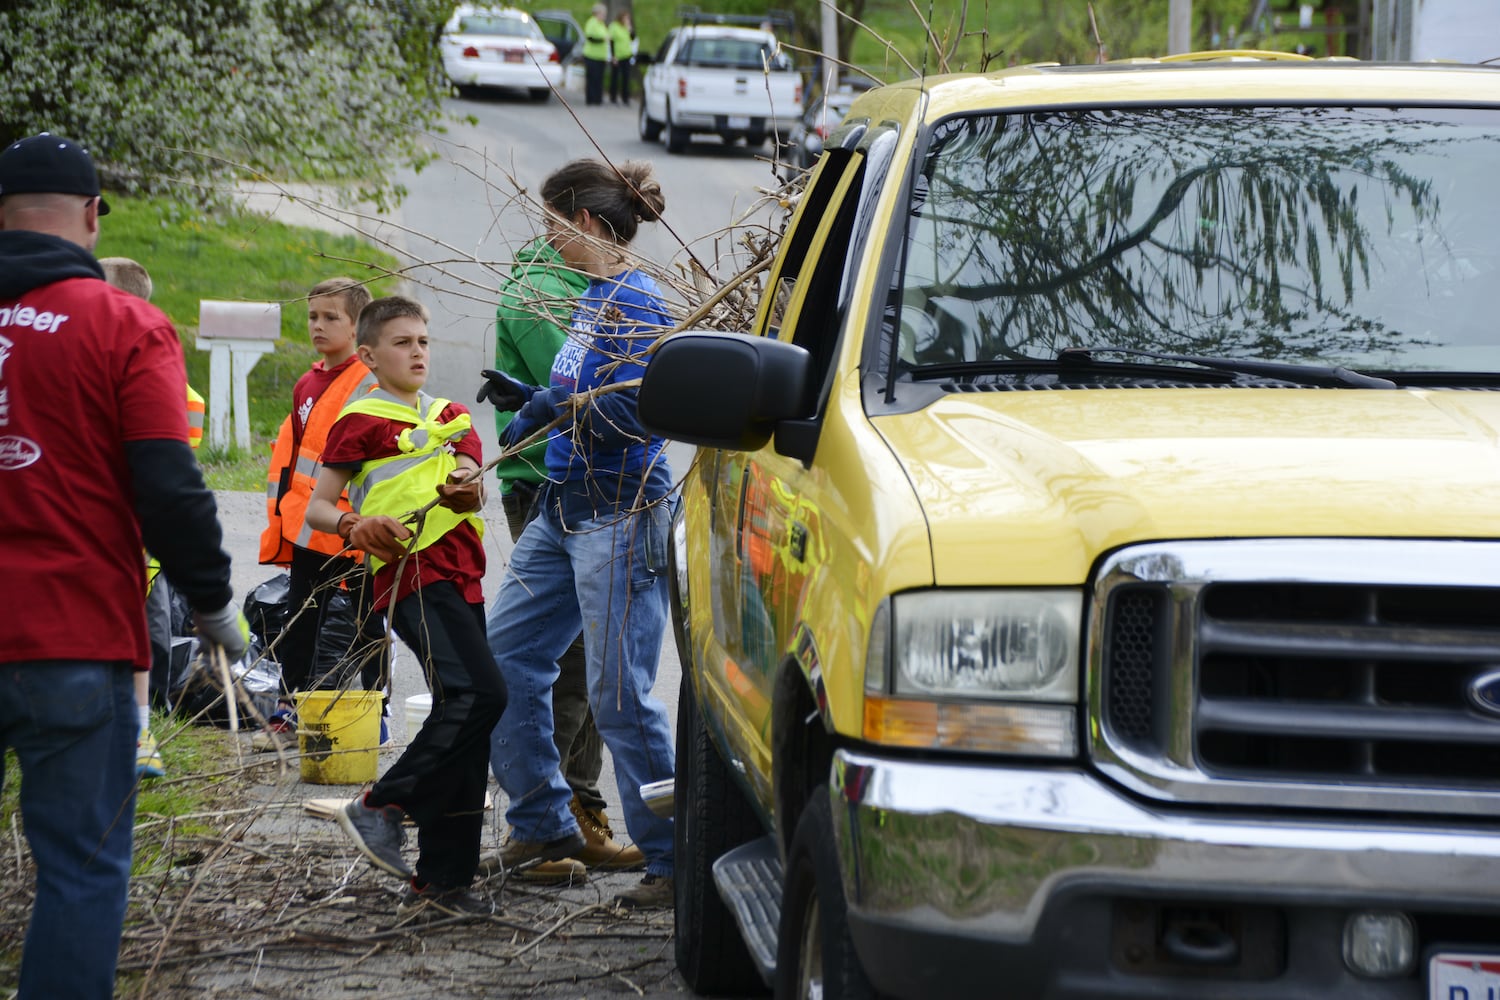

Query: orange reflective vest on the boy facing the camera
left=261, top=360, right=377, bottom=565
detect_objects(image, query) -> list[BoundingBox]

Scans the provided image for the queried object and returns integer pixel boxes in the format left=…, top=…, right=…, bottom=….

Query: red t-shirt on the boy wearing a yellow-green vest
left=323, top=403, right=485, bottom=610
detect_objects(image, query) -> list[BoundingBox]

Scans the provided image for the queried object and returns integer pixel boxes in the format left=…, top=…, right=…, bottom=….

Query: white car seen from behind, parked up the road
left=440, top=4, right=563, bottom=100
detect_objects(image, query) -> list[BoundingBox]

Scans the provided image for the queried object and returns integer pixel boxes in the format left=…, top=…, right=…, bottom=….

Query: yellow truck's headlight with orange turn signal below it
left=864, top=589, right=1083, bottom=756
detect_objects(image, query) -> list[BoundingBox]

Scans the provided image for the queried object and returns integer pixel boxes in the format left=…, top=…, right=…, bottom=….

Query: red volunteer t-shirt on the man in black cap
left=0, top=277, right=188, bottom=669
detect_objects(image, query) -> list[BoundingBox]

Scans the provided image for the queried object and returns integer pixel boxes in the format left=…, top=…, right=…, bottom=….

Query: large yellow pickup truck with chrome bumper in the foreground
left=641, top=52, right=1500, bottom=1000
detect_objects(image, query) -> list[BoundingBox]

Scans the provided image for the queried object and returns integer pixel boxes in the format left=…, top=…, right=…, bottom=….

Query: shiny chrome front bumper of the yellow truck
left=833, top=751, right=1500, bottom=997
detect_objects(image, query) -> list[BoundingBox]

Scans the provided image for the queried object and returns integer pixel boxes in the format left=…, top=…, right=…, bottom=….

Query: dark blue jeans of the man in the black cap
left=0, top=660, right=141, bottom=1000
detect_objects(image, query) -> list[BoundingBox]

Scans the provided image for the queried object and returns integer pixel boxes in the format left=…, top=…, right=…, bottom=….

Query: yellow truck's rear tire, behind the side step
left=672, top=676, right=765, bottom=997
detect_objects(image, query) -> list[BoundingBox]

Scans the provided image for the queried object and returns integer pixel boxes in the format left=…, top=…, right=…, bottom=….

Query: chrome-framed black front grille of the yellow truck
left=1089, top=540, right=1500, bottom=814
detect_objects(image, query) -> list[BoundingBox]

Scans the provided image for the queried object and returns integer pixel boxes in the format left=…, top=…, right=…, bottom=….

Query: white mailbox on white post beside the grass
left=198, top=298, right=281, bottom=448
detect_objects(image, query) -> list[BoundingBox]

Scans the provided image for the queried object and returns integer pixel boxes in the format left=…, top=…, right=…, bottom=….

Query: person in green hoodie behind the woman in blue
left=476, top=237, right=645, bottom=882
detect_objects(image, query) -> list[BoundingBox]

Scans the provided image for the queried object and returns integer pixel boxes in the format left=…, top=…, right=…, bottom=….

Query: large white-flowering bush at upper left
left=0, top=0, right=452, bottom=204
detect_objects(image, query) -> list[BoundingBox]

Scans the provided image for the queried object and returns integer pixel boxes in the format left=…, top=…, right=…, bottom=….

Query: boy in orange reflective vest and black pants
left=261, top=277, right=390, bottom=733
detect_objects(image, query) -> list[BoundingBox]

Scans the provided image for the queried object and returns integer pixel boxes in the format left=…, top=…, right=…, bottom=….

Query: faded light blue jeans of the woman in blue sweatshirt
left=486, top=502, right=674, bottom=876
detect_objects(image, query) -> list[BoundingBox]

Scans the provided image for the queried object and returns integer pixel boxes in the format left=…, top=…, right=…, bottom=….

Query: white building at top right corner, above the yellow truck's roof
left=1371, top=0, right=1500, bottom=64
